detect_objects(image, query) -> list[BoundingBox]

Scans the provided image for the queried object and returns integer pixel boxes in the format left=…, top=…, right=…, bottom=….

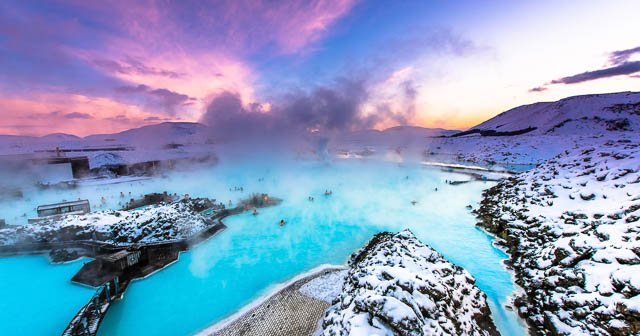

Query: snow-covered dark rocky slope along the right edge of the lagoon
left=476, top=137, right=640, bottom=335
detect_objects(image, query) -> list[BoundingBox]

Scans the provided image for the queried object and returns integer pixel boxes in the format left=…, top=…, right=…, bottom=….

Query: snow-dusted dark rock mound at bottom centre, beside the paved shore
left=317, top=230, right=499, bottom=335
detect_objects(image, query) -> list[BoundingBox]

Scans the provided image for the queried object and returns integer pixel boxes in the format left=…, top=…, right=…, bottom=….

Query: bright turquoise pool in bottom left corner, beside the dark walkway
left=0, top=256, right=95, bottom=335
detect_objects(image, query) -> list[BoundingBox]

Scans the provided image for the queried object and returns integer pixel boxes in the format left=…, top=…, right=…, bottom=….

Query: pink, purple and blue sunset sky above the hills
left=0, top=0, right=640, bottom=136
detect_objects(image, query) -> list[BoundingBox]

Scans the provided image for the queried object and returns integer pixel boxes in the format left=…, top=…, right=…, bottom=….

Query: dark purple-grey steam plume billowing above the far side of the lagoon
left=201, top=79, right=417, bottom=140
